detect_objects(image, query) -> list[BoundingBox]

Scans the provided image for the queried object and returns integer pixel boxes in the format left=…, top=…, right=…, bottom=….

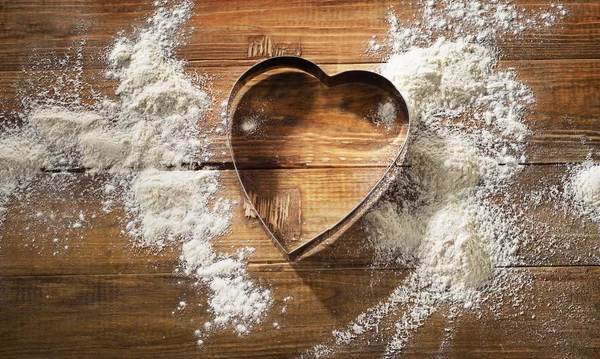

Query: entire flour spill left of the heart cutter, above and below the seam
left=0, top=1, right=272, bottom=338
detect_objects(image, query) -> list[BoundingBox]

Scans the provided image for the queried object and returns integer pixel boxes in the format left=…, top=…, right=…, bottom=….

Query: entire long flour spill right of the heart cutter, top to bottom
left=306, top=1, right=566, bottom=357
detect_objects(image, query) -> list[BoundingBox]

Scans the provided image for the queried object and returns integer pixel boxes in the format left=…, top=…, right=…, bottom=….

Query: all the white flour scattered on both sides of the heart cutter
left=0, top=0, right=600, bottom=357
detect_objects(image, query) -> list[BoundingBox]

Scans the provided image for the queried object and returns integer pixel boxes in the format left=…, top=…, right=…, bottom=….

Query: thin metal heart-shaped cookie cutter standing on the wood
left=226, top=56, right=411, bottom=261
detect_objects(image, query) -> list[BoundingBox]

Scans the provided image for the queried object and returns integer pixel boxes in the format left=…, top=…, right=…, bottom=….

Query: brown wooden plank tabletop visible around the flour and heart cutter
left=0, top=0, right=600, bottom=358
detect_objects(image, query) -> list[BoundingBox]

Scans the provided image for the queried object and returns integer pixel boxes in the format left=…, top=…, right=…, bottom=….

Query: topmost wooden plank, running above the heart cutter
left=0, top=0, right=600, bottom=71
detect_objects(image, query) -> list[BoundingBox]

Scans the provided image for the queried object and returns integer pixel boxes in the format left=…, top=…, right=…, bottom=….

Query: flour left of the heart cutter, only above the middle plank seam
left=2, top=2, right=211, bottom=173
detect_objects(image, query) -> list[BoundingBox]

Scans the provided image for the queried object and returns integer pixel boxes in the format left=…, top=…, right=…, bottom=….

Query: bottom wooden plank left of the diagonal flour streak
left=0, top=270, right=406, bottom=358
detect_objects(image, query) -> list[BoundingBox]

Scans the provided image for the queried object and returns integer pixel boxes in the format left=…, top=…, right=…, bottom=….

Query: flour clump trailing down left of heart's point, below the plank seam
left=127, top=170, right=272, bottom=337
